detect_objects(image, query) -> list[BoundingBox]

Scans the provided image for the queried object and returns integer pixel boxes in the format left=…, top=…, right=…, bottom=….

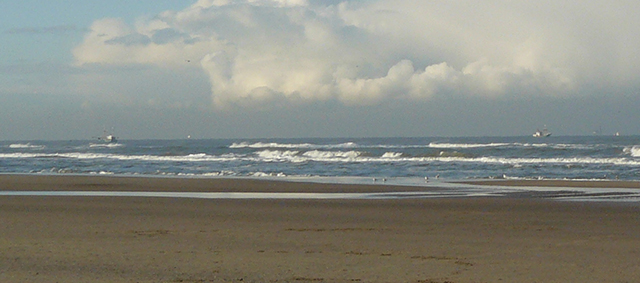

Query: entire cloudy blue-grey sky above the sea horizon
left=0, top=0, right=640, bottom=140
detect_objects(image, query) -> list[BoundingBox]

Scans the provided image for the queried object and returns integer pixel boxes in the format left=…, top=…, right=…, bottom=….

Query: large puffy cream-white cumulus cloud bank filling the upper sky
left=73, top=0, right=640, bottom=108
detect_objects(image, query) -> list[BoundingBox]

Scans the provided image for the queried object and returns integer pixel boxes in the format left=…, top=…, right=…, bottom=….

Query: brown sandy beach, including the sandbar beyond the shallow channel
left=0, top=175, right=640, bottom=283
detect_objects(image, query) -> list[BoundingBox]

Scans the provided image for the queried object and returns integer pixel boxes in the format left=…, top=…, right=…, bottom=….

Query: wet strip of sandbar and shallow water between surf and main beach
left=0, top=174, right=640, bottom=204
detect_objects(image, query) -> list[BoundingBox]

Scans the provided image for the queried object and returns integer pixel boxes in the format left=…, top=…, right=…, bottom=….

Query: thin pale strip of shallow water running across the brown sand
left=0, top=177, right=640, bottom=203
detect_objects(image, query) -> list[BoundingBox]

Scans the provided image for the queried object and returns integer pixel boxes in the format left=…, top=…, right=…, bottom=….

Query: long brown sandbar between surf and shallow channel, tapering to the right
left=0, top=174, right=436, bottom=193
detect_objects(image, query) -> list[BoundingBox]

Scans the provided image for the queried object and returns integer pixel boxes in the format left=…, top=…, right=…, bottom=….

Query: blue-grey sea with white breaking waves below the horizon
left=0, top=136, right=640, bottom=180
